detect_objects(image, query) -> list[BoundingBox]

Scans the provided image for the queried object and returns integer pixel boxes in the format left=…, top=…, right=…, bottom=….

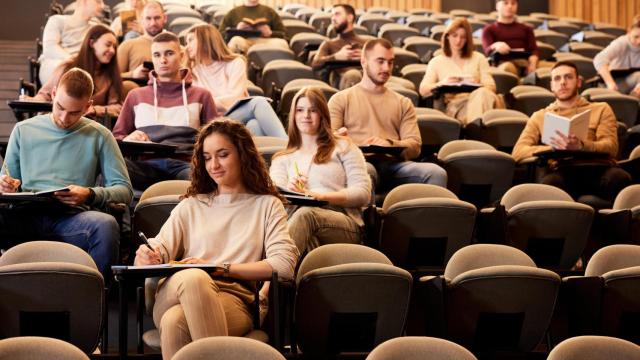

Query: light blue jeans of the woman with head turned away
left=225, top=97, right=288, bottom=139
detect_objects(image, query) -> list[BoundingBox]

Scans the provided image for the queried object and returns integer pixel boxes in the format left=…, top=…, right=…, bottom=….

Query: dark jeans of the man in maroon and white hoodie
left=125, top=158, right=191, bottom=190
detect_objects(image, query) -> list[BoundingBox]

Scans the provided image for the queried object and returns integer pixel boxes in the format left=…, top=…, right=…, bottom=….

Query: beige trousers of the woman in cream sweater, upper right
left=446, top=87, right=504, bottom=124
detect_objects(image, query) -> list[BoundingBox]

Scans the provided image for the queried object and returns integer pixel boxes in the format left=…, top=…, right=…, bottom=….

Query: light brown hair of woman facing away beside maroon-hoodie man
left=186, top=24, right=242, bottom=79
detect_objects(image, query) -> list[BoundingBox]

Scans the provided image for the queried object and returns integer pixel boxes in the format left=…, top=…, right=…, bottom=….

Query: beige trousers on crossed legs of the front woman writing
left=153, top=269, right=254, bottom=360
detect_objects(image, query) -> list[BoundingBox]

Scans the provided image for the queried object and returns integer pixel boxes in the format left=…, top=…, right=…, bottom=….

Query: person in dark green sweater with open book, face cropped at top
left=220, top=0, right=289, bottom=55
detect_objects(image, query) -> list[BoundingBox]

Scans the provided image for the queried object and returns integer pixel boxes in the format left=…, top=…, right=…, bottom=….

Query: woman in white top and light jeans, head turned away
left=187, top=25, right=287, bottom=139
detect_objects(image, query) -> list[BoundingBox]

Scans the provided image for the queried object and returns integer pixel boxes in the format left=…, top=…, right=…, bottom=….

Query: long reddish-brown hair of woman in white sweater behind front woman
left=273, top=86, right=336, bottom=164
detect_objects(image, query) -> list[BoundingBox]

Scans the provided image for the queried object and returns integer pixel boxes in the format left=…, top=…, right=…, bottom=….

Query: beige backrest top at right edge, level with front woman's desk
left=584, top=244, right=640, bottom=276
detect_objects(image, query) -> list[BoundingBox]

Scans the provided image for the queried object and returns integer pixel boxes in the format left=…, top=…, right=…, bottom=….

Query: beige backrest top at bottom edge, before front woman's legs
left=172, top=336, right=285, bottom=360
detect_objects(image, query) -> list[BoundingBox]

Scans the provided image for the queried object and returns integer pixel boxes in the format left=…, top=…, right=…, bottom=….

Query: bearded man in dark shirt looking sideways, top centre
left=311, top=4, right=365, bottom=90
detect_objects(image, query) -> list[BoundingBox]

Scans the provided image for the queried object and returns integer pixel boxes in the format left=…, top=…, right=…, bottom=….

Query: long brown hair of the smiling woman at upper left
left=64, top=25, right=124, bottom=102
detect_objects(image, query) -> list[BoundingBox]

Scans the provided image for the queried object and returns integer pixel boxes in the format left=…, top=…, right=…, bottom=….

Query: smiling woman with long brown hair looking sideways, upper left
left=20, top=25, right=124, bottom=118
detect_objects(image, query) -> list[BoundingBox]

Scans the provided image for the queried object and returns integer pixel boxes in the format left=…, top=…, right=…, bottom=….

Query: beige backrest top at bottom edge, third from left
left=367, top=336, right=476, bottom=360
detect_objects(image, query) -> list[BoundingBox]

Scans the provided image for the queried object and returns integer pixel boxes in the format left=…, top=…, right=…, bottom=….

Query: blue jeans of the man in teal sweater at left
left=0, top=205, right=120, bottom=282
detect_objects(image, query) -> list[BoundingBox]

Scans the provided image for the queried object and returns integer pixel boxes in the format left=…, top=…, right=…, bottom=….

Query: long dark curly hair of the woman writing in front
left=185, top=118, right=284, bottom=200
